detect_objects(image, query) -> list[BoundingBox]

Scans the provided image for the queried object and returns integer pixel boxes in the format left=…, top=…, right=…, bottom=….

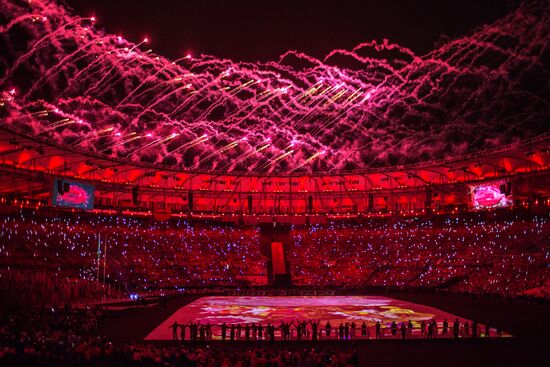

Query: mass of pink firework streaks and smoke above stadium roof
left=0, top=0, right=550, bottom=172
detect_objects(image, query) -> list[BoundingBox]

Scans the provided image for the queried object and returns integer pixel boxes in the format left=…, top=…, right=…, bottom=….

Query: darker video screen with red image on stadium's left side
left=52, top=179, right=95, bottom=210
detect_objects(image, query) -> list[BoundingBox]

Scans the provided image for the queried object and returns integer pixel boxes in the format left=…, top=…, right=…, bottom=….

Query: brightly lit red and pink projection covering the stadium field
left=145, top=296, right=478, bottom=340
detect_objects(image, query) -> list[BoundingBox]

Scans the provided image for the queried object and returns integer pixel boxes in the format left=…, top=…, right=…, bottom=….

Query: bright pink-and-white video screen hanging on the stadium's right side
left=470, top=180, right=512, bottom=210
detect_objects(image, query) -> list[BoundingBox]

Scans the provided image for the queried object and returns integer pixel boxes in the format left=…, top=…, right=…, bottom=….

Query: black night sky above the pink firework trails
left=65, top=0, right=519, bottom=61
